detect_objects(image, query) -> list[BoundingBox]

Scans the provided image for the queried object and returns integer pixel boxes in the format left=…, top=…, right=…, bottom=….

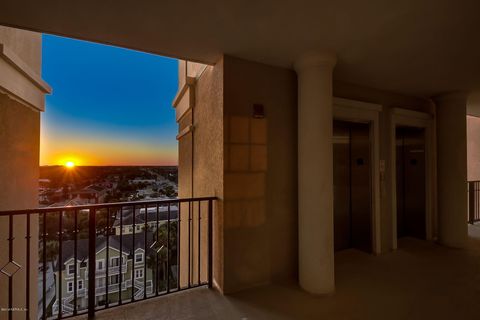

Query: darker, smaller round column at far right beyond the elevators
left=435, top=93, right=468, bottom=248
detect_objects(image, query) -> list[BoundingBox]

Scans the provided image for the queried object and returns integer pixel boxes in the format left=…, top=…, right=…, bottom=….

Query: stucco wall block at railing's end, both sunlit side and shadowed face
left=177, top=57, right=297, bottom=293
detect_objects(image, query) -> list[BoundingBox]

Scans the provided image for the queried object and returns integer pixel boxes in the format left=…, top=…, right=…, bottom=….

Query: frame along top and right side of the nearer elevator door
left=332, top=98, right=382, bottom=254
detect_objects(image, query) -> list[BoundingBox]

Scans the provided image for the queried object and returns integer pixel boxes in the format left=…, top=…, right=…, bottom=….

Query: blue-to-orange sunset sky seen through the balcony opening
left=40, top=35, right=178, bottom=165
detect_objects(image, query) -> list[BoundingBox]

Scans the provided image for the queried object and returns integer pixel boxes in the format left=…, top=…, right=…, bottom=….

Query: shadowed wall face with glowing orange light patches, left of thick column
left=224, top=57, right=298, bottom=292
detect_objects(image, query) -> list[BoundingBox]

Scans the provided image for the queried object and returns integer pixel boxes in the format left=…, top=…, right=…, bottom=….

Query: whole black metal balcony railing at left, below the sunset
left=0, top=197, right=215, bottom=319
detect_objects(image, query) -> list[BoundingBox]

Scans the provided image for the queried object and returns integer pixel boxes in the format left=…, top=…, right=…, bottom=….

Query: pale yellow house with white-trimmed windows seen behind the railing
left=53, top=232, right=154, bottom=315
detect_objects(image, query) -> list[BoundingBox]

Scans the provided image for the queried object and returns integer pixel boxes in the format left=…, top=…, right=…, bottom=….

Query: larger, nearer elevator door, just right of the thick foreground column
left=333, top=121, right=372, bottom=252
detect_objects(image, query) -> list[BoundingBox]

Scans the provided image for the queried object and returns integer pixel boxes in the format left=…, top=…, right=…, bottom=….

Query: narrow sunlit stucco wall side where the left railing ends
left=192, top=60, right=224, bottom=287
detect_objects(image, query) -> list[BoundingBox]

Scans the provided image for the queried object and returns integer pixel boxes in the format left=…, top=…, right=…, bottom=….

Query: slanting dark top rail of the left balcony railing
left=0, top=197, right=218, bottom=217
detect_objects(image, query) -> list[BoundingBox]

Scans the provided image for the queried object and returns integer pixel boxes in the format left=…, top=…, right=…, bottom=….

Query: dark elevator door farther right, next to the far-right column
left=396, top=127, right=426, bottom=239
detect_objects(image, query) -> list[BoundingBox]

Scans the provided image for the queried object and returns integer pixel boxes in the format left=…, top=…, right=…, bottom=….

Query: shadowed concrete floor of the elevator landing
left=88, top=226, right=480, bottom=320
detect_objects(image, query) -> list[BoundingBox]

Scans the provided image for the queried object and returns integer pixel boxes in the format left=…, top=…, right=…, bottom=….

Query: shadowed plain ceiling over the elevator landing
left=0, top=0, right=480, bottom=97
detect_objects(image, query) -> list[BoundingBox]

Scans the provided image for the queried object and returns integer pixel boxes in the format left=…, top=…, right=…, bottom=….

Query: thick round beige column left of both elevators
left=295, top=53, right=336, bottom=294
